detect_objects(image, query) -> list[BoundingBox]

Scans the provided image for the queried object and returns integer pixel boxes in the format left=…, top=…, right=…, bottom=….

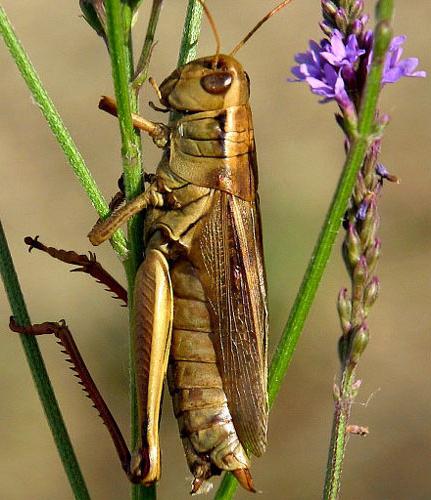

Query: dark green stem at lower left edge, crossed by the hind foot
left=0, top=221, right=90, bottom=500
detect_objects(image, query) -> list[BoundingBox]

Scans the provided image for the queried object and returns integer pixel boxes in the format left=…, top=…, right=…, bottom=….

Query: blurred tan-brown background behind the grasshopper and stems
left=0, top=0, right=431, bottom=500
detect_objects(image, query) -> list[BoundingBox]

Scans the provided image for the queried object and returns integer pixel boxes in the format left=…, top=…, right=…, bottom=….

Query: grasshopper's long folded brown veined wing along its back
left=197, top=191, right=268, bottom=456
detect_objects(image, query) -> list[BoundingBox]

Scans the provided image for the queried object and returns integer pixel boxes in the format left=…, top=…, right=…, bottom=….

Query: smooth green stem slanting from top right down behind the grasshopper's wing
left=214, top=0, right=392, bottom=500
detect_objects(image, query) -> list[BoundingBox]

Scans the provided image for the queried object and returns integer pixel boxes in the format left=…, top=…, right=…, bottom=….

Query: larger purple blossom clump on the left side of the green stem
left=292, top=30, right=365, bottom=108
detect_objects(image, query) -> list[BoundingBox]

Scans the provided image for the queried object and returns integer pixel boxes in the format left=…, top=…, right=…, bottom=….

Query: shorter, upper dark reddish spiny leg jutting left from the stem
left=24, top=236, right=127, bottom=305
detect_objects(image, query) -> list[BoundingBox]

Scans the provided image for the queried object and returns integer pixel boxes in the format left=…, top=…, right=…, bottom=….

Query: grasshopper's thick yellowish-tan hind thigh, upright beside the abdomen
left=132, top=244, right=173, bottom=484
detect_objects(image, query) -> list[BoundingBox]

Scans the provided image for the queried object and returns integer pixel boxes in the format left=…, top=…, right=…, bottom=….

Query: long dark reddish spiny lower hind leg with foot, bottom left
left=9, top=317, right=144, bottom=483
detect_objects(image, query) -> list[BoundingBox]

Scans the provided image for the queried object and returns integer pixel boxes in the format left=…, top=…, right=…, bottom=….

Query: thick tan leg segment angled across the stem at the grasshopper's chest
left=88, top=184, right=164, bottom=246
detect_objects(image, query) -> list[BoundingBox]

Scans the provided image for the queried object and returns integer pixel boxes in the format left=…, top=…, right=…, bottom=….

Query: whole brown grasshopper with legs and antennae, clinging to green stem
left=11, top=0, right=290, bottom=493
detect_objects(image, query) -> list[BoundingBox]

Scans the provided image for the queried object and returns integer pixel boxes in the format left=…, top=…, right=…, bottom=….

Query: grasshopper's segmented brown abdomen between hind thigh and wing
left=168, top=259, right=249, bottom=492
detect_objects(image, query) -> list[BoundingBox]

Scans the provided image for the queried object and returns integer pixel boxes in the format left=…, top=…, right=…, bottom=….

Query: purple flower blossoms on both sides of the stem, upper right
left=291, top=29, right=426, bottom=109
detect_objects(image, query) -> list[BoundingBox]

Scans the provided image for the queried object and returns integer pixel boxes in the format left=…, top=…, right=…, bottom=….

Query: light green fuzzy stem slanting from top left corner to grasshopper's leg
left=0, top=5, right=127, bottom=257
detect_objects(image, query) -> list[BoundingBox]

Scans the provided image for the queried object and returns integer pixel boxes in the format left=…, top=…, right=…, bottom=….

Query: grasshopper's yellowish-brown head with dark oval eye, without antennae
left=160, top=54, right=250, bottom=113
